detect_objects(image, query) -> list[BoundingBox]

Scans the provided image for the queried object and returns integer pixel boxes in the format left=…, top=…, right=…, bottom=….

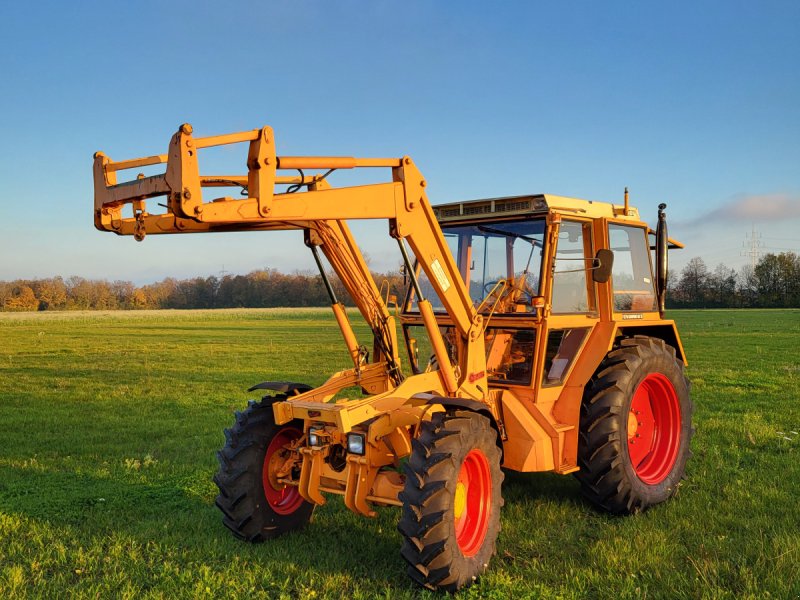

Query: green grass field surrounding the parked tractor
left=0, top=309, right=800, bottom=599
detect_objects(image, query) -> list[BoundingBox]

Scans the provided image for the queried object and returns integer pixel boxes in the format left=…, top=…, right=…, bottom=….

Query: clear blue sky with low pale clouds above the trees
left=0, top=0, right=800, bottom=284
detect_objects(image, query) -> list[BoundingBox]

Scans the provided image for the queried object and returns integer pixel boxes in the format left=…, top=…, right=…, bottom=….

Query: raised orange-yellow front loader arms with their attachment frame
left=94, top=124, right=488, bottom=400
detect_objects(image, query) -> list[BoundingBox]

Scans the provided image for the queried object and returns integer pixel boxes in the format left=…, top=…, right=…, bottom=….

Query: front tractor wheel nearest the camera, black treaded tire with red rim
left=397, top=411, right=503, bottom=592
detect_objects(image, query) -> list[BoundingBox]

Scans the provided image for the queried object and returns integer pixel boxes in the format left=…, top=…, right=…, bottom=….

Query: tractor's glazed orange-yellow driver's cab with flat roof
left=402, top=195, right=676, bottom=402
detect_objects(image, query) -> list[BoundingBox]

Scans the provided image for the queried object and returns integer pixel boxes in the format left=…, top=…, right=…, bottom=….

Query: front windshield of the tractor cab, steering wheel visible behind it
left=408, top=219, right=545, bottom=313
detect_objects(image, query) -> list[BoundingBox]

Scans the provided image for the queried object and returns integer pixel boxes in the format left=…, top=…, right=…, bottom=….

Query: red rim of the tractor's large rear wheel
left=628, top=373, right=681, bottom=485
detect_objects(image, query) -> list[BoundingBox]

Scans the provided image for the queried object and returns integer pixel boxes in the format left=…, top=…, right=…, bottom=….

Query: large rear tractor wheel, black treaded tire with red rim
left=576, top=336, right=694, bottom=514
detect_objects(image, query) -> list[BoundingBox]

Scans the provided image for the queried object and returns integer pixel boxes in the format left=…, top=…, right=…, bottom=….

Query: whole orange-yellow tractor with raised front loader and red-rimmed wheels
left=94, top=124, right=693, bottom=591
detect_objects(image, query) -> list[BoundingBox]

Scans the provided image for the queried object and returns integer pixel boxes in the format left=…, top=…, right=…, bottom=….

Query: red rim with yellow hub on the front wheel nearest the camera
left=453, top=449, right=492, bottom=556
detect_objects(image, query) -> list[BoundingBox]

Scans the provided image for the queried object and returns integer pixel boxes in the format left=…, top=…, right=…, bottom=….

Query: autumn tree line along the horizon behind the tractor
left=0, top=252, right=800, bottom=311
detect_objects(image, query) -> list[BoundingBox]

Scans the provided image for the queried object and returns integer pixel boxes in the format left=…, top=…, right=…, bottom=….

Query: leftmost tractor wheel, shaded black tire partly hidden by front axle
left=214, top=398, right=314, bottom=542
